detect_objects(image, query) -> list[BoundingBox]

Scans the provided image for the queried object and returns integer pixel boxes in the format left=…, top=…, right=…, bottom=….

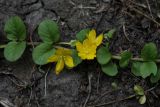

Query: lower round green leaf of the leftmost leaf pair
left=4, top=41, right=26, bottom=62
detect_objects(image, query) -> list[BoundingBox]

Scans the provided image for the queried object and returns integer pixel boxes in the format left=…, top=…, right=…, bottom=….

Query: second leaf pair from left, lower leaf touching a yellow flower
left=32, top=20, right=60, bottom=65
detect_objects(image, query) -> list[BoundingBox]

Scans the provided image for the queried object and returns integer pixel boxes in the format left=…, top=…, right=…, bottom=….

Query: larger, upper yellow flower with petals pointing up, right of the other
left=76, top=30, right=103, bottom=60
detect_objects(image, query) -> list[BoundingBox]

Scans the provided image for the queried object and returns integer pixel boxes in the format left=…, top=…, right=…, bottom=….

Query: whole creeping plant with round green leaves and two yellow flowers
left=0, top=16, right=160, bottom=83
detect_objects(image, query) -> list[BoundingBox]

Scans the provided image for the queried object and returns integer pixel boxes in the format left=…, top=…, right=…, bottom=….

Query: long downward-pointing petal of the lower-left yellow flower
left=55, top=57, right=64, bottom=75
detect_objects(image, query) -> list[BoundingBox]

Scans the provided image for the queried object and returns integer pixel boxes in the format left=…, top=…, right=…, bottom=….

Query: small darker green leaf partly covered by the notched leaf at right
left=131, top=62, right=142, bottom=76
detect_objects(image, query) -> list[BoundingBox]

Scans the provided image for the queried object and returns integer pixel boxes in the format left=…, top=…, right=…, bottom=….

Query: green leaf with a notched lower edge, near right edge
left=140, top=62, right=157, bottom=78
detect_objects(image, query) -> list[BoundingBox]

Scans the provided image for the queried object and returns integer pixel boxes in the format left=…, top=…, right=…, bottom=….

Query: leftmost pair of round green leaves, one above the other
left=4, top=16, right=26, bottom=62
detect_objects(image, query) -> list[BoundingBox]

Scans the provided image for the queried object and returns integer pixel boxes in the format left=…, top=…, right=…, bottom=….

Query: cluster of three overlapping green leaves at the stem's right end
left=131, top=43, right=160, bottom=80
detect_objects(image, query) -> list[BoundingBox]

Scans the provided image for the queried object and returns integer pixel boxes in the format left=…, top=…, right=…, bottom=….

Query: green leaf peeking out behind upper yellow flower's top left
left=76, top=29, right=90, bottom=42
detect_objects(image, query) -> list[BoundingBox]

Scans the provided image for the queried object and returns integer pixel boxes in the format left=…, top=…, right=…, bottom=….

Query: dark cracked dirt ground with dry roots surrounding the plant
left=0, top=0, right=160, bottom=107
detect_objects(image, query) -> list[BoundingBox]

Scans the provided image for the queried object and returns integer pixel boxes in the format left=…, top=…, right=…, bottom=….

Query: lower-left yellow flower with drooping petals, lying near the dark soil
left=48, top=48, right=74, bottom=75
